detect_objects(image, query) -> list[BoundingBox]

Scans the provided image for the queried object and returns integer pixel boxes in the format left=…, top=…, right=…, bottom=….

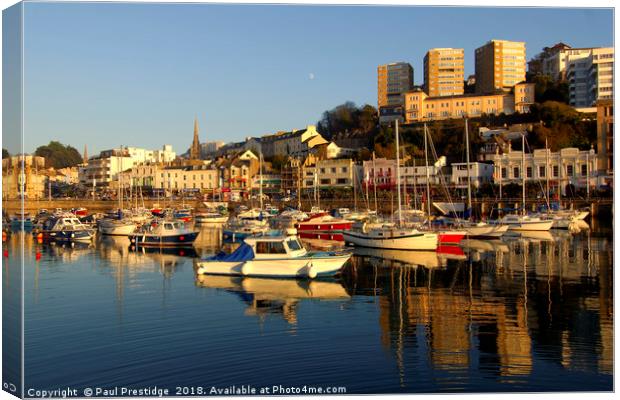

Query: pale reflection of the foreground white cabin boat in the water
left=196, top=275, right=351, bottom=325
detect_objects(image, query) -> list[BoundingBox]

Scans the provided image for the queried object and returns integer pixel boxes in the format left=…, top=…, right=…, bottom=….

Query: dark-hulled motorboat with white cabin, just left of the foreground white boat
left=129, top=220, right=200, bottom=247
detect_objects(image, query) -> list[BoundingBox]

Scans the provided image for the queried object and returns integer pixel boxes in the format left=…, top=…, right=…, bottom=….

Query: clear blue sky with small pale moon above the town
left=12, top=3, right=613, bottom=155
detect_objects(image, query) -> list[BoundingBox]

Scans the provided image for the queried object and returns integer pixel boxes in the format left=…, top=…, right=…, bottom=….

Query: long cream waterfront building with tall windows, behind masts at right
left=493, top=147, right=597, bottom=195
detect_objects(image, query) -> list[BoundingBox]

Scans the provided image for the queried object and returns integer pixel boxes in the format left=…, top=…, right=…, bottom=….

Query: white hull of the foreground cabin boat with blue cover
left=196, top=254, right=351, bottom=279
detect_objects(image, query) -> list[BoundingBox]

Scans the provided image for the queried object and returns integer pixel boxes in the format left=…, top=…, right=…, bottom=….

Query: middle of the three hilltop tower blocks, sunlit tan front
left=424, top=48, right=465, bottom=97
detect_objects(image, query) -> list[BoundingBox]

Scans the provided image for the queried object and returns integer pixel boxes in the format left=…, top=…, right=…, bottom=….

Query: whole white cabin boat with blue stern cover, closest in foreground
left=196, top=236, right=351, bottom=279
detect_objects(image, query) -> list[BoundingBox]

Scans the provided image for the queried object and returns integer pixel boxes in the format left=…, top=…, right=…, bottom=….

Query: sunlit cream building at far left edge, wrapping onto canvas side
left=2, top=154, right=48, bottom=200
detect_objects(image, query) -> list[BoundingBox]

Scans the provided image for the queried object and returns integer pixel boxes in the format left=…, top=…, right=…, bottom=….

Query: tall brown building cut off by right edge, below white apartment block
left=596, top=100, right=614, bottom=175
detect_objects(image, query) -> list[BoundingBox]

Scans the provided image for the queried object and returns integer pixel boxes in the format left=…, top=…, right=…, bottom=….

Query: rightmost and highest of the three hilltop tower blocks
left=476, top=40, right=525, bottom=93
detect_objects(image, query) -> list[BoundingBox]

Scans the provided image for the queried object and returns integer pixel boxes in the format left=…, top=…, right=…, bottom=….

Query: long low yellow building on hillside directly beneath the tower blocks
left=404, top=83, right=534, bottom=123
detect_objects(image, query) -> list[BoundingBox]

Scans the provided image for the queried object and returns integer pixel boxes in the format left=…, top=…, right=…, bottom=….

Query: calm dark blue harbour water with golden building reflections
left=3, top=225, right=613, bottom=395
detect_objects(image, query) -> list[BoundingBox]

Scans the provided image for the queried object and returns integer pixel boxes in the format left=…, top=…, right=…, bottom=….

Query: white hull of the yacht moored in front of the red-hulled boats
left=342, top=232, right=439, bottom=250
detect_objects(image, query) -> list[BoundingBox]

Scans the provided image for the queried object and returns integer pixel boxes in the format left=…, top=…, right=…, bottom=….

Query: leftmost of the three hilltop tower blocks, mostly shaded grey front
left=377, top=62, right=413, bottom=109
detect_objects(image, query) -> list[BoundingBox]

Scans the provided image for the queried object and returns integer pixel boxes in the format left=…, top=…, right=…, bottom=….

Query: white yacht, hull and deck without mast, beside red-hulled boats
left=342, top=226, right=439, bottom=250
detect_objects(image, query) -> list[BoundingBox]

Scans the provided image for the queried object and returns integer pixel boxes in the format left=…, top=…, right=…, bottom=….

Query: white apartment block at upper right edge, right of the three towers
left=564, top=47, right=614, bottom=108
